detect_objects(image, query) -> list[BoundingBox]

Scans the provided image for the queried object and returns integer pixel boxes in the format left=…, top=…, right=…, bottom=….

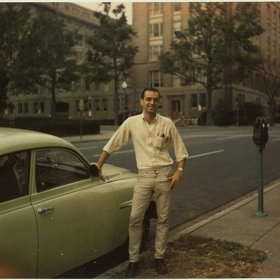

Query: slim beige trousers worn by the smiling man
left=129, top=166, right=173, bottom=262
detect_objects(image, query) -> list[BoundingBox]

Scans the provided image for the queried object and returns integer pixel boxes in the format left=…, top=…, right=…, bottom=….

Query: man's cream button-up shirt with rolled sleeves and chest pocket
left=103, top=114, right=188, bottom=169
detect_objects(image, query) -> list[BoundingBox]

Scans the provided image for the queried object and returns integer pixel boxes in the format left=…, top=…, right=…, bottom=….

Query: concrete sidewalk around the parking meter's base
left=169, top=179, right=280, bottom=278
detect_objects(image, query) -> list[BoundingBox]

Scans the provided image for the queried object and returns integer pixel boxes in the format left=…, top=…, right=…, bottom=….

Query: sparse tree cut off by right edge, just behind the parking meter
left=257, top=56, right=280, bottom=126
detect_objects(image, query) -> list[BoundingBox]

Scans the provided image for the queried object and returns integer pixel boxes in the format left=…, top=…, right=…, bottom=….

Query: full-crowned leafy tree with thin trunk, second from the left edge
left=10, top=12, right=80, bottom=118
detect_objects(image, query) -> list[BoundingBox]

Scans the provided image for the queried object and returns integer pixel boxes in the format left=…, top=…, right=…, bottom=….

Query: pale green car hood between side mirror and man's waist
left=102, top=164, right=137, bottom=182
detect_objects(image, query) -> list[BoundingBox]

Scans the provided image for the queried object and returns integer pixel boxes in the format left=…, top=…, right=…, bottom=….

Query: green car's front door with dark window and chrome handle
left=32, top=148, right=117, bottom=278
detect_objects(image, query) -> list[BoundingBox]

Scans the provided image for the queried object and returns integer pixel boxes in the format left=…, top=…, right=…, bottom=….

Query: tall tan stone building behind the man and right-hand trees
left=132, top=2, right=280, bottom=119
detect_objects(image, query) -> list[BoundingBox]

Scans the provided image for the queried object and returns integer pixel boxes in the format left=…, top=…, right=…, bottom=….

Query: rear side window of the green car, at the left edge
left=0, top=151, right=30, bottom=203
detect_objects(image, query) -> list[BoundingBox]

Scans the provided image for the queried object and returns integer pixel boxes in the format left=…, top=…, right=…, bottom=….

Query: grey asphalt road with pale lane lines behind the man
left=68, top=125, right=280, bottom=278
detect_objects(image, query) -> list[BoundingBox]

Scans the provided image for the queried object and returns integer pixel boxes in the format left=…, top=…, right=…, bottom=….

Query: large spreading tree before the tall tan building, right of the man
left=159, top=2, right=263, bottom=125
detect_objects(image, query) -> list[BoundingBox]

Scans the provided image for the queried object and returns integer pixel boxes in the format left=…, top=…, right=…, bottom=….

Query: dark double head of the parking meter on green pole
left=253, top=117, right=269, bottom=149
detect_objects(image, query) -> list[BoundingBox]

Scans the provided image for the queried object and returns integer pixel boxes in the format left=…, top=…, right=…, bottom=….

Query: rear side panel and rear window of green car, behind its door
left=0, top=151, right=38, bottom=278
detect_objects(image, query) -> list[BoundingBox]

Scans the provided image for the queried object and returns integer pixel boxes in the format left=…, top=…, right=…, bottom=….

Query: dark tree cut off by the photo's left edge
left=0, top=3, right=30, bottom=115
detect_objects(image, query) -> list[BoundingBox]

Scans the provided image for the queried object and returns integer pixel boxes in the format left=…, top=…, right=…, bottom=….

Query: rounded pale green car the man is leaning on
left=0, top=128, right=155, bottom=278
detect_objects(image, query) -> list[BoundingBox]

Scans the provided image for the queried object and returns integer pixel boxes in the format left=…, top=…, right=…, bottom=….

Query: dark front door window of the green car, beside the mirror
left=35, top=148, right=90, bottom=192
